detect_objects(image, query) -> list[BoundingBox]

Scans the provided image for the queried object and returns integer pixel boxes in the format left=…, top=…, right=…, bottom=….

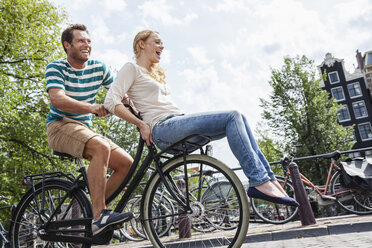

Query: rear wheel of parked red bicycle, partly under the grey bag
left=331, top=171, right=372, bottom=215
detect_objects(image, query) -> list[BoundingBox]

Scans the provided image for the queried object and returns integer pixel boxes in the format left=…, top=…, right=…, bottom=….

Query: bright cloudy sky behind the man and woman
left=51, top=0, right=372, bottom=184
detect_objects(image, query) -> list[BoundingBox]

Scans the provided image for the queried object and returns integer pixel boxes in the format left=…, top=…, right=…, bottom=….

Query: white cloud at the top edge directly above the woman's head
left=139, top=0, right=198, bottom=26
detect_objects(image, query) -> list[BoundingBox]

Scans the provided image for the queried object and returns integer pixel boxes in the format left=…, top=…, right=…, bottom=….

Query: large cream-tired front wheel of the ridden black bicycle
left=141, top=154, right=249, bottom=247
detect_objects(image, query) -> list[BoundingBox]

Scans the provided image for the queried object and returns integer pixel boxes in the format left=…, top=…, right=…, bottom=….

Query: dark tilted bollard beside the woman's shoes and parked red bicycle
left=289, top=162, right=316, bottom=226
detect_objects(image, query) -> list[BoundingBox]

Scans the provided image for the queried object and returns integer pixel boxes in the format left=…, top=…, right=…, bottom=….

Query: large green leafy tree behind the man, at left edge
left=0, top=0, right=66, bottom=203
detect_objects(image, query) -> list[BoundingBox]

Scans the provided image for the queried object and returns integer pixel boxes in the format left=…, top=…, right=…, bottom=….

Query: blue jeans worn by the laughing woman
left=152, top=111, right=275, bottom=187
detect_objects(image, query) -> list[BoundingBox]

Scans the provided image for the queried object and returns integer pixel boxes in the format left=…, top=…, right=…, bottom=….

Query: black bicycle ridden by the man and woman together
left=10, top=103, right=249, bottom=248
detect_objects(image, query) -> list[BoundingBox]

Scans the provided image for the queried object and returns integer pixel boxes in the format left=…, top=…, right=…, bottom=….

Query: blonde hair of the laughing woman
left=133, top=29, right=166, bottom=84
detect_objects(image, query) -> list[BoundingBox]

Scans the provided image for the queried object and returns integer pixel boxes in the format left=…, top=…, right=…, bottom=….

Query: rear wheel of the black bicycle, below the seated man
left=11, top=179, right=93, bottom=248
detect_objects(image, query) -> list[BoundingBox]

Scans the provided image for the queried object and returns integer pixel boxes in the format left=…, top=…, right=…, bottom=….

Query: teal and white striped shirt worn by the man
left=45, top=59, right=113, bottom=127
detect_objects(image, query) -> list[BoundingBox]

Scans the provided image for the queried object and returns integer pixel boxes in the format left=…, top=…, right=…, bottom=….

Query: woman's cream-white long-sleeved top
left=104, top=62, right=183, bottom=130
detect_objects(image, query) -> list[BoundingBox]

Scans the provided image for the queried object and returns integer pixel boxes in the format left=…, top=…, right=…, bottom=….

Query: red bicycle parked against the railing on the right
left=251, top=147, right=372, bottom=224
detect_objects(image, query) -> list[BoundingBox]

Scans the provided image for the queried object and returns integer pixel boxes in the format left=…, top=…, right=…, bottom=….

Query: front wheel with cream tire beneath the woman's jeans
left=142, top=155, right=249, bottom=247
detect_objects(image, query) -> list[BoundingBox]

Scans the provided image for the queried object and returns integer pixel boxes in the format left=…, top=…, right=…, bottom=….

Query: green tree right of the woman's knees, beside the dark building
left=260, top=56, right=354, bottom=183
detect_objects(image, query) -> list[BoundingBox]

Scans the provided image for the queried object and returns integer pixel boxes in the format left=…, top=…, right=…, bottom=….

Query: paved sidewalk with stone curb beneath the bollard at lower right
left=94, top=215, right=372, bottom=248
